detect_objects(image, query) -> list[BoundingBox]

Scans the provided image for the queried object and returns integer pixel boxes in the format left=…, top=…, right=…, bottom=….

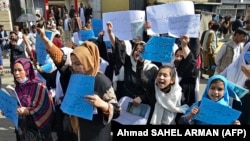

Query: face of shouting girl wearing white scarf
left=156, top=68, right=174, bottom=89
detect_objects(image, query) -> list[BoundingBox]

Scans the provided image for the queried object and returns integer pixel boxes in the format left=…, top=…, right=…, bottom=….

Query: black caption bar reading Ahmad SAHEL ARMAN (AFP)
left=112, top=125, right=250, bottom=141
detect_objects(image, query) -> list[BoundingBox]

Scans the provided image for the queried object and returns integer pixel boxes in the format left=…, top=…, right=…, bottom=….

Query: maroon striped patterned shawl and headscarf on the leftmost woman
left=15, top=58, right=52, bottom=129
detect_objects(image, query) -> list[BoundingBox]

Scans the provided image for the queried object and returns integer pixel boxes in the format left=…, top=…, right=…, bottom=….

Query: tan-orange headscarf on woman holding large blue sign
left=71, top=41, right=100, bottom=76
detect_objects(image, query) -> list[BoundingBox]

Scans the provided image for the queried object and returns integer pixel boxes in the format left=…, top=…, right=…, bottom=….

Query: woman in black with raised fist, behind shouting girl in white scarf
left=107, top=22, right=158, bottom=104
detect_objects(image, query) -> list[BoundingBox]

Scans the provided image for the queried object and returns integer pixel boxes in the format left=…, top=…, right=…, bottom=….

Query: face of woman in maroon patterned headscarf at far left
left=13, top=63, right=26, bottom=82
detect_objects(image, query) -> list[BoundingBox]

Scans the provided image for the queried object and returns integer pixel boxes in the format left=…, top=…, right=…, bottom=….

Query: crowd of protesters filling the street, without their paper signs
left=0, top=3, right=250, bottom=141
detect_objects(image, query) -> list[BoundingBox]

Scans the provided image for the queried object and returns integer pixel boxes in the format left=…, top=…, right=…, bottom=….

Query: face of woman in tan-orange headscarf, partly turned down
left=71, top=54, right=86, bottom=74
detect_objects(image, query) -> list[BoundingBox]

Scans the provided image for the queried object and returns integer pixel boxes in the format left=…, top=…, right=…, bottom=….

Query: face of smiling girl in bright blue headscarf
left=208, top=81, right=225, bottom=101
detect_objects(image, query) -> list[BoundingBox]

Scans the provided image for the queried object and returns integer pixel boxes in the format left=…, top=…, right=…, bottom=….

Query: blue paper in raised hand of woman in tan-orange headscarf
left=36, top=31, right=52, bottom=65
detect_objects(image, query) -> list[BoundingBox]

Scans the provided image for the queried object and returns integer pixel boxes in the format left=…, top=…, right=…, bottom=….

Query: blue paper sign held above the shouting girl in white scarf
left=141, top=36, right=175, bottom=63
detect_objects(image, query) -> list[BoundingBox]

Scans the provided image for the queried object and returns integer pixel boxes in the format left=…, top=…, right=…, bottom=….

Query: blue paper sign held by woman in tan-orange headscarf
left=60, top=74, right=95, bottom=120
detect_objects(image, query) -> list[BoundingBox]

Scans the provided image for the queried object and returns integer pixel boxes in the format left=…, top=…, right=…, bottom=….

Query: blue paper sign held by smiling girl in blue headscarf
left=194, top=98, right=241, bottom=125
